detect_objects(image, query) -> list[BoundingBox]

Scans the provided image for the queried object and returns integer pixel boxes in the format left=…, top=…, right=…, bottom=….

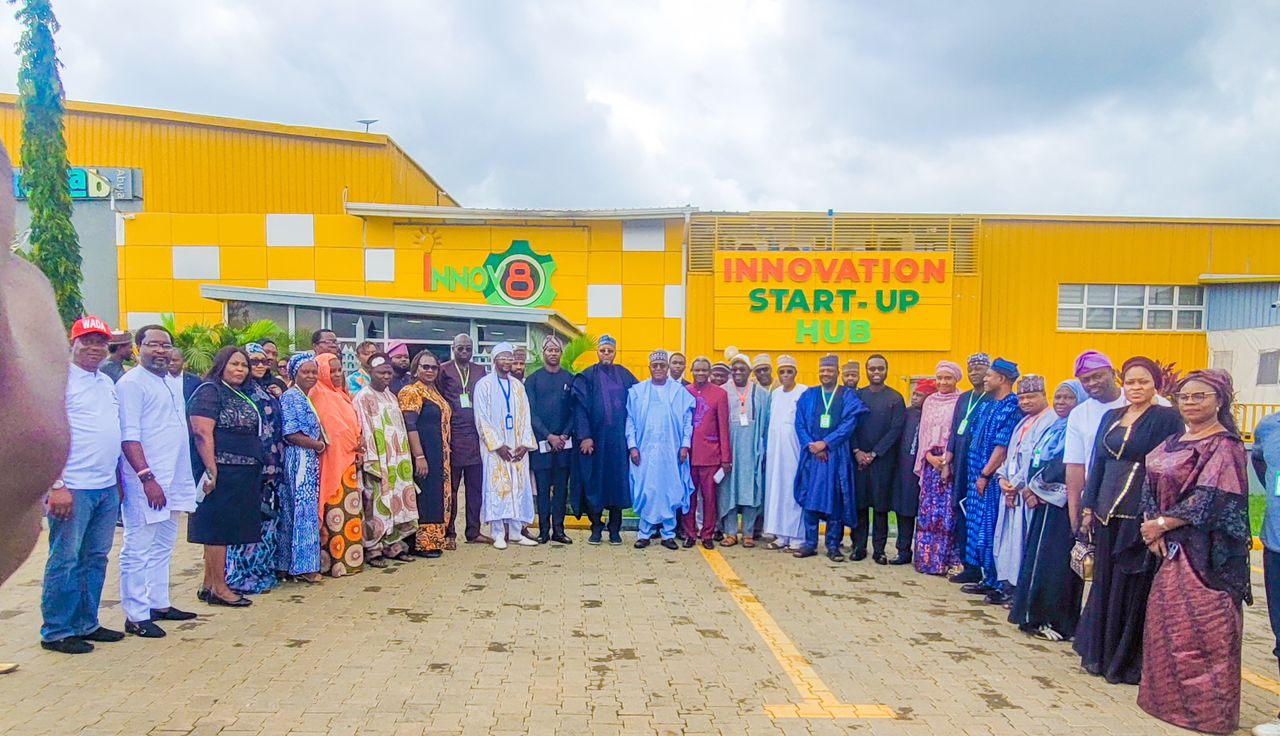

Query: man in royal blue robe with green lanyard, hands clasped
left=795, top=355, right=867, bottom=562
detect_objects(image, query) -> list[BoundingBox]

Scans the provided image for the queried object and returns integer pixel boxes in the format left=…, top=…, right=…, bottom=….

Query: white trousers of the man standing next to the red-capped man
left=120, top=511, right=178, bottom=623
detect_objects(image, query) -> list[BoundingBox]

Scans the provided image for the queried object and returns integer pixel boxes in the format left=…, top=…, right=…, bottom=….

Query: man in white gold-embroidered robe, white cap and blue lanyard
left=474, top=343, right=538, bottom=549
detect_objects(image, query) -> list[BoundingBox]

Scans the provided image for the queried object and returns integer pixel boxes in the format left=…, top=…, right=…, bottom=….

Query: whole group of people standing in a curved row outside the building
left=41, top=317, right=1264, bottom=732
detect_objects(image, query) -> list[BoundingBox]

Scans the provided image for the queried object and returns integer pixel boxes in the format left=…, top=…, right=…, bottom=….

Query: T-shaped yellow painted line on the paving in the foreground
left=698, top=548, right=897, bottom=718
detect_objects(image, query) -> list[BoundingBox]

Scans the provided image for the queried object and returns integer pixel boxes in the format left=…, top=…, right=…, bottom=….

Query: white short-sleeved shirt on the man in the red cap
left=63, top=364, right=120, bottom=490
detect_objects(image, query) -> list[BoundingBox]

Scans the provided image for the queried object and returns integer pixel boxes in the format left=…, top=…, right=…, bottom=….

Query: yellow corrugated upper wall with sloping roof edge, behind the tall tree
left=0, top=96, right=456, bottom=214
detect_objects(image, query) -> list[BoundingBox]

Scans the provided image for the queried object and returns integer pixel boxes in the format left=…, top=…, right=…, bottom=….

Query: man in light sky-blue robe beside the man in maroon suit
left=627, top=351, right=695, bottom=549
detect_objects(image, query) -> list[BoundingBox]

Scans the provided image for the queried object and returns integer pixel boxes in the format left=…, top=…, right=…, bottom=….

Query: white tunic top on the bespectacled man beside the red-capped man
left=115, top=367, right=196, bottom=526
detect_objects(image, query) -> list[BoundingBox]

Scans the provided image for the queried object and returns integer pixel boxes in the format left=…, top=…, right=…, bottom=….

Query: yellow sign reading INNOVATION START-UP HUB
left=716, top=251, right=952, bottom=351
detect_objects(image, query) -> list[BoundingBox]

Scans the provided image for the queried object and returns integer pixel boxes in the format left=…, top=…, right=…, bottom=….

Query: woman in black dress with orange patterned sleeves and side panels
left=399, top=349, right=453, bottom=558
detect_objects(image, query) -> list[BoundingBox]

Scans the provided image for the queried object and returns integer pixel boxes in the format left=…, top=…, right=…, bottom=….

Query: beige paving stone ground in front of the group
left=0, top=522, right=1280, bottom=736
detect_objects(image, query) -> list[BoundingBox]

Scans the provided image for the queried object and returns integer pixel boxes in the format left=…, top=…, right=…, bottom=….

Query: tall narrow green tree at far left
left=10, top=0, right=84, bottom=326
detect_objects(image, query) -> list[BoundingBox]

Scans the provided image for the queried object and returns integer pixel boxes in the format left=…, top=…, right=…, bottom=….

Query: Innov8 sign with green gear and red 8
left=422, top=241, right=556, bottom=307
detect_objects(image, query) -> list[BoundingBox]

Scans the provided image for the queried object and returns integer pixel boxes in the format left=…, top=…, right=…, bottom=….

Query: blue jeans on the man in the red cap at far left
left=40, top=485, right=120, bottom=641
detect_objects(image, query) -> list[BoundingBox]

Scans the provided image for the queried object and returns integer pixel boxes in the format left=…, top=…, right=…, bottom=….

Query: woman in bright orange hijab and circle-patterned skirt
left=310, top=355, right=365, bottom=577
